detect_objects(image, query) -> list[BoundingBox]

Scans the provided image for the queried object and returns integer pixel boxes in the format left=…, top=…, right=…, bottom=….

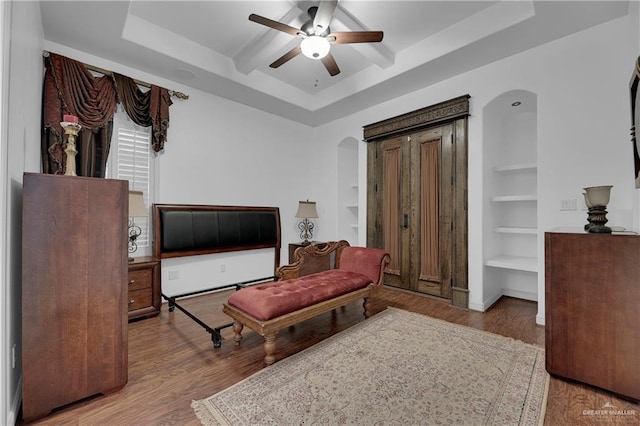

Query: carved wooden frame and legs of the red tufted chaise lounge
left=223, top=241, right=389, bottom=365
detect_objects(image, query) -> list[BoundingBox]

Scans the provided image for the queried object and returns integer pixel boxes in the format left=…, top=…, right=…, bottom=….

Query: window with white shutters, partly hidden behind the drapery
left=107, top=107, right=155, bottom=256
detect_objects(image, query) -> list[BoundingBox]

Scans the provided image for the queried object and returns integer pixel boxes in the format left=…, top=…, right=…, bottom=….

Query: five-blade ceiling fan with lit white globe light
left=249, top=0, right=383, bottom=76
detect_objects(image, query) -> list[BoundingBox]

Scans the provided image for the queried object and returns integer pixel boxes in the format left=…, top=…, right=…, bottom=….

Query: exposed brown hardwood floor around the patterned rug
left=21, top=287, right=640, bottom=426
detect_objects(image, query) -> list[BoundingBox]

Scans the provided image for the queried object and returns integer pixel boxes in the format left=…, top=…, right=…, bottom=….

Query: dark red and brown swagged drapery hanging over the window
left=41, top=53, right=171, bottom=177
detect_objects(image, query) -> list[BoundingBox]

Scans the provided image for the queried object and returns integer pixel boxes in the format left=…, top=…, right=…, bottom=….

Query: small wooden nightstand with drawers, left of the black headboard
left=127, top=256, right=161, bottom=320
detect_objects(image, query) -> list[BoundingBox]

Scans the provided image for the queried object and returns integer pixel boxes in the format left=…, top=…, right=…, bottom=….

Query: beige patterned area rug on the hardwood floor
left=192, top=308, right=549, bottom=426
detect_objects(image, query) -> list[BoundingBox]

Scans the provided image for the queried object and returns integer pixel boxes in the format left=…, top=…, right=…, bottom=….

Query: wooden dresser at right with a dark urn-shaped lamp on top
left=545, top=232, right=640, bottom=400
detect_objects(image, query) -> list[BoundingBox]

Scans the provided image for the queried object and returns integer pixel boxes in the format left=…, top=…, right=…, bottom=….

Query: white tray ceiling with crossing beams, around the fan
left=40, top=0, right=629, bottom=126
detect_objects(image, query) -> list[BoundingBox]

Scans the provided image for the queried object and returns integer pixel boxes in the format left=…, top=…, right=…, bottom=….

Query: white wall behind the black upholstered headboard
left=152, top=89, right=318, bottom=295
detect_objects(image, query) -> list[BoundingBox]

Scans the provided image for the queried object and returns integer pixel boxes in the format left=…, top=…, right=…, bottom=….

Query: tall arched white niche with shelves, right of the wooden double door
left=483, top=90, right=541, bottom=309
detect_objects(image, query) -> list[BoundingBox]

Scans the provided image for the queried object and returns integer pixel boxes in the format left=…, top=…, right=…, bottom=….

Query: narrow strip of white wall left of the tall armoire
left=0, top=2, right=42, bottom=424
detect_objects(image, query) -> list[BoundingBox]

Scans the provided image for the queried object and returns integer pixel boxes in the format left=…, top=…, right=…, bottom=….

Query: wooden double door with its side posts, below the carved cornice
left=367, top=96, right=468, bottom=307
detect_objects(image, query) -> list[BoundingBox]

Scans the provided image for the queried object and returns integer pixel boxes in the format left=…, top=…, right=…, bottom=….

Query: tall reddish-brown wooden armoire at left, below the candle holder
left=22, top=174, right=129, bottom=421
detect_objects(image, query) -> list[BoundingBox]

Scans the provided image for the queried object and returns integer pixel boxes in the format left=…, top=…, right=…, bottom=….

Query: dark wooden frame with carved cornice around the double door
left=363, top=95, right=470, bottom=308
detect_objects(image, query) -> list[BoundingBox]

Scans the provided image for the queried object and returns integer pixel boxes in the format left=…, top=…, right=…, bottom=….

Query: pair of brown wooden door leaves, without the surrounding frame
left=376, top=125, right=453, bottom=298
